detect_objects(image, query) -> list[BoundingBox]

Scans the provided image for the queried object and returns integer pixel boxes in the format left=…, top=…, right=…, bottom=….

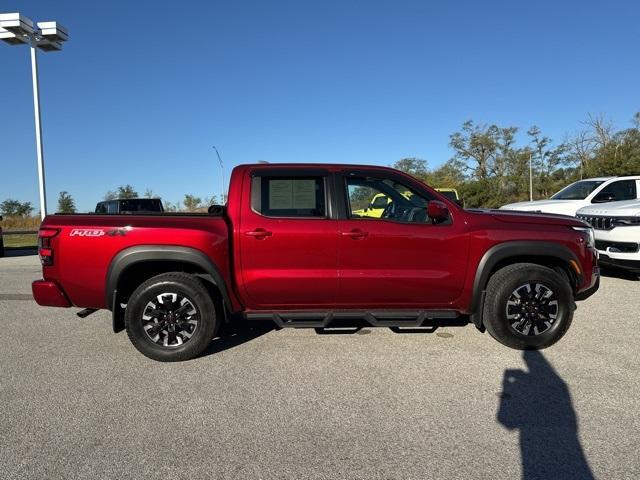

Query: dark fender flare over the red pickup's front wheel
left=470, top=241, right=581, bottom=330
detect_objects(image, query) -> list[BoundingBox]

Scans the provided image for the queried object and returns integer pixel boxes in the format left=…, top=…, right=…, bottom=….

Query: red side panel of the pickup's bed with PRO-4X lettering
left=41, top=213, right=231, bottom=308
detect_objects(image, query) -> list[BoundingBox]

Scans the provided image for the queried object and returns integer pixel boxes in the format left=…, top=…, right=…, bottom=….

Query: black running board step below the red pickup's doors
left=244, top=310, right=459, bottom=328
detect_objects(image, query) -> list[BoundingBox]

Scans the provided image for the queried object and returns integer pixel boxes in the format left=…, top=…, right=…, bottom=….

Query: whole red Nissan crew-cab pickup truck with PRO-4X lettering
left=33, top=164, right=599, bottom=361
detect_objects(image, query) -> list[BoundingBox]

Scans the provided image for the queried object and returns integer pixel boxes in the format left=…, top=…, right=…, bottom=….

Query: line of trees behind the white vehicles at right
left=393, top=112, right=640, bottom=208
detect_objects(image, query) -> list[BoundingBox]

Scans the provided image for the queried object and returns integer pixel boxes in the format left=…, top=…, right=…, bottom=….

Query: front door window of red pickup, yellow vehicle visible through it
left=346, top=177, right=431, bottom=223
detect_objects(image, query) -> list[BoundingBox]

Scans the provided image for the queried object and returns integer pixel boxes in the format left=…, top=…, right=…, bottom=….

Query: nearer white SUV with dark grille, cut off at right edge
left=577, top=200, right=640, bottom=272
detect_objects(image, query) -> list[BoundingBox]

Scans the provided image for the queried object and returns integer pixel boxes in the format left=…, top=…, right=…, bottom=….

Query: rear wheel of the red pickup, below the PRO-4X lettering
left=125, top=272, right=218, bottom=362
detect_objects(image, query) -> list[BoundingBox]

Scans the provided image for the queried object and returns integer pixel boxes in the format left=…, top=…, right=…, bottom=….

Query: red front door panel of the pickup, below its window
left=338, top=220, right=468, bottom=307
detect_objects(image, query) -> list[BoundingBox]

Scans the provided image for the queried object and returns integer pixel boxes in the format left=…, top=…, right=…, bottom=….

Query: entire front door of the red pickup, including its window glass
left=338, top=172, right=469, bottom=308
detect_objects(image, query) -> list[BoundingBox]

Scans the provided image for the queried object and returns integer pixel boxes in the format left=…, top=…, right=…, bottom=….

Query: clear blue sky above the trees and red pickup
left=0, top=0, right=640, bottom=210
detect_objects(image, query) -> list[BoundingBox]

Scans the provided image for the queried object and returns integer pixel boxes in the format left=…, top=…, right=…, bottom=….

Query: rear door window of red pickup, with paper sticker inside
left=251, top=176, right=327, bottom=218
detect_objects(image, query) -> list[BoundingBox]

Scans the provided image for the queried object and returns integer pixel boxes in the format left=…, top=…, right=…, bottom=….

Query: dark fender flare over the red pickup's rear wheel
left=105, top=245, right=233, bottom=309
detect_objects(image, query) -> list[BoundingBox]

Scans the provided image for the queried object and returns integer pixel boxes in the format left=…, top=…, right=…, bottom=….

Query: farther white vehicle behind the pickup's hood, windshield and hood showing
left=500, top=176, right=640, bottom=216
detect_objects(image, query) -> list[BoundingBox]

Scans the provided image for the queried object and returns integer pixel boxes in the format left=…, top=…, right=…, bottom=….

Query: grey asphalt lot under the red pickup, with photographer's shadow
left=0, top=255, right=640, bottom=480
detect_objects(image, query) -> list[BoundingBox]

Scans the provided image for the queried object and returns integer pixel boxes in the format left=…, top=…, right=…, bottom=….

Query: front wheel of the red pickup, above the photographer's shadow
left=483, top=263, right=575, bottom=350
